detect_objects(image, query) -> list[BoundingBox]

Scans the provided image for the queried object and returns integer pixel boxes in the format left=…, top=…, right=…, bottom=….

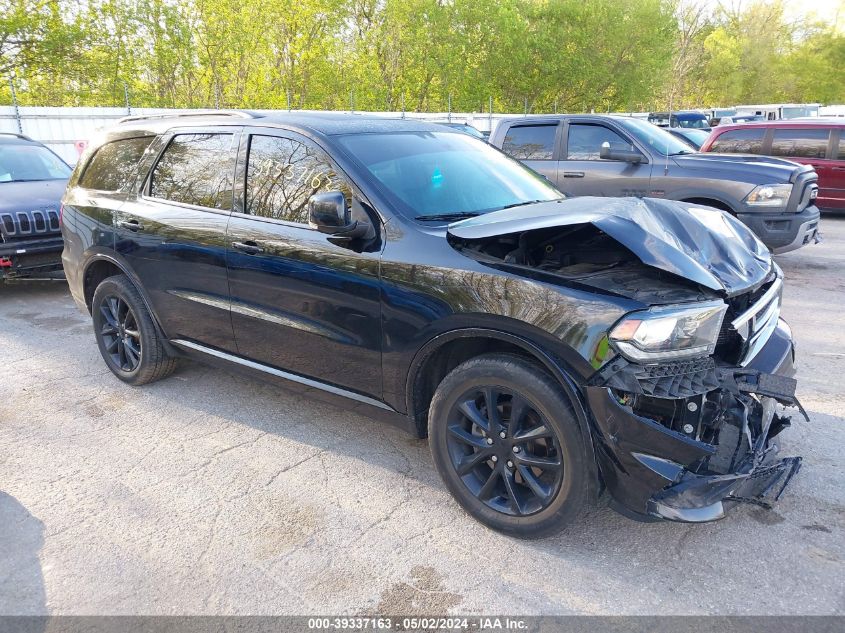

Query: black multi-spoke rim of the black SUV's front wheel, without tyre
left=447, top=386, right=564, bottom=516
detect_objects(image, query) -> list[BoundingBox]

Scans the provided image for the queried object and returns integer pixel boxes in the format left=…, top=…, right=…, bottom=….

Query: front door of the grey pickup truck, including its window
left=558, top=119, right=651, bottom=196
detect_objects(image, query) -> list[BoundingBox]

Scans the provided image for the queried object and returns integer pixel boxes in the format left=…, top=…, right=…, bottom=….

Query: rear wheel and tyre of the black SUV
left=91, top=275, right=176, bottom=385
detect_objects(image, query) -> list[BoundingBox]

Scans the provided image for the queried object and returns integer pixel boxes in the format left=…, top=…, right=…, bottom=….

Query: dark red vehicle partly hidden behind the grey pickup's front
left=701, top=119, right=845, bottom=211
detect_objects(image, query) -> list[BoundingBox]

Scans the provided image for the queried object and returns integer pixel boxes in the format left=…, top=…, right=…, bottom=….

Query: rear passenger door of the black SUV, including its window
left=115, top=127, right=240, bottom=350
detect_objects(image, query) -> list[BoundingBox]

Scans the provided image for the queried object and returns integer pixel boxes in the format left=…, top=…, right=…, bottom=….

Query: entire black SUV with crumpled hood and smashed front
left=63, top=112, right=800, bottom=536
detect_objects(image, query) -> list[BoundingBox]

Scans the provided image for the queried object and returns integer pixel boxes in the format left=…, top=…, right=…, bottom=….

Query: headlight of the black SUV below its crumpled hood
left=610, top=301, right=728, bottom=363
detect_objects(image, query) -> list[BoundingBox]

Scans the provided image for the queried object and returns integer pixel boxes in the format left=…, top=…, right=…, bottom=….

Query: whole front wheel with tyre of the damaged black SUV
left=429, top=354, right=588, bottom=538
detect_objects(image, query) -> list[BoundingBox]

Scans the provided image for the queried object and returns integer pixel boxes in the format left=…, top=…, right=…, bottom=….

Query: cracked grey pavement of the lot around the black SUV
left=0, top=218, right=845, bottom=615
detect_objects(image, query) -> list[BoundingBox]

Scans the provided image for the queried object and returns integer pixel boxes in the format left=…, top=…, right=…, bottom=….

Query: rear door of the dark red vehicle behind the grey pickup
left=769, top=125, right=845, bottom=209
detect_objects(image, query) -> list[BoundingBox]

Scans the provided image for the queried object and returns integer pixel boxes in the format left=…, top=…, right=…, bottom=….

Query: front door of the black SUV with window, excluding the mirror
left=227, top=129, right=381, bottom=398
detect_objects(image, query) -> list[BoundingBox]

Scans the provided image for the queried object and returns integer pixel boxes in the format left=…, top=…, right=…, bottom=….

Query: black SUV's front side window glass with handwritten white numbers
left=245, top=135, right=352, bottom=224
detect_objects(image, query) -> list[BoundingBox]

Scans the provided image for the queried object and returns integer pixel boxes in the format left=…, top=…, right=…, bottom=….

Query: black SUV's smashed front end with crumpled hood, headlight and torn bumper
left=449, top=198, right=806, bottom=522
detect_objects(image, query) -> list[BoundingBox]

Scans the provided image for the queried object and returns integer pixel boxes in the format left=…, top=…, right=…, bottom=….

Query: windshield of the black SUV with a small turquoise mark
left=338, top=132, right=563, bottom=220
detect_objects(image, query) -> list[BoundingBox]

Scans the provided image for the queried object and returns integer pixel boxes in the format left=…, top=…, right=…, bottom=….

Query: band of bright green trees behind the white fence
left=0, top=0, right=845, bottom=112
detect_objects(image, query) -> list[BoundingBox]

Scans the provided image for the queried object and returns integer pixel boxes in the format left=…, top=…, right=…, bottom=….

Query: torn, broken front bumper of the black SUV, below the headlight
left=586, top=321, right=803, bottom=522
